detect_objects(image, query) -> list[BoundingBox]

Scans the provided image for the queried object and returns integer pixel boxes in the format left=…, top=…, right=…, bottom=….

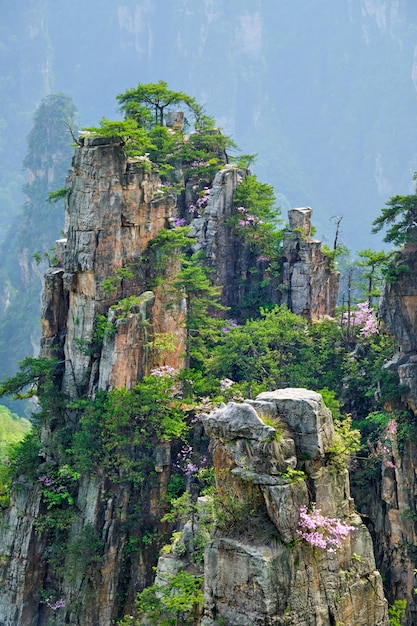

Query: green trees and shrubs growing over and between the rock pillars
left=0, top=84, right=416, bottom=624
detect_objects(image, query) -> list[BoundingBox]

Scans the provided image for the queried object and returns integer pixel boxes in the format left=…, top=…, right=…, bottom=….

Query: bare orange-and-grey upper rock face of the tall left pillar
left=42, top=137, right=185, bottom=396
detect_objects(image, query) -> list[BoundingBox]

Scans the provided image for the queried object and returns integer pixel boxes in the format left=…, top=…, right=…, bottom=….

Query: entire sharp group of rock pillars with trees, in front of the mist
left=0, top=81, right=417, bottom=626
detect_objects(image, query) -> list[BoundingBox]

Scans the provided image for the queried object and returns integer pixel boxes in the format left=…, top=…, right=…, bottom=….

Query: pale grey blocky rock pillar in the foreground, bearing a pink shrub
left=203, top=389, right=388, bottom=626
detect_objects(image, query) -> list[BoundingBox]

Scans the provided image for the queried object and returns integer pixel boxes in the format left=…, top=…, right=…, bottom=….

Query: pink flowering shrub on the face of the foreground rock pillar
left=297, top=502, right=355, bottom=552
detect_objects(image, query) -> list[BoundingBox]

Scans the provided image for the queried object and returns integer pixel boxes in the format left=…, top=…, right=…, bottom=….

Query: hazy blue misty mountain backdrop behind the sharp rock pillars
left=0, top=0, right=417, bottom=408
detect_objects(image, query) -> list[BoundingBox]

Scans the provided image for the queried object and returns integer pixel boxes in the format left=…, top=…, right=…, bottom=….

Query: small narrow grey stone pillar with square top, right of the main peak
left=282, top=207, right=339, bottom=320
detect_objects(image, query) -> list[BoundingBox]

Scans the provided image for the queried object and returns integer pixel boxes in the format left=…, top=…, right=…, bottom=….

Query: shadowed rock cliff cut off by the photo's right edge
left=357, top=246, right=417, bottom=626
